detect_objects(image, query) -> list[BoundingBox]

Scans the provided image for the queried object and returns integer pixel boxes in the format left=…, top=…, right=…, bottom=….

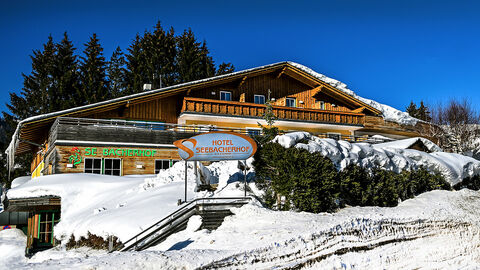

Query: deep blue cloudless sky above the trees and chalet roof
left=0, top=0, right=480, bottom=114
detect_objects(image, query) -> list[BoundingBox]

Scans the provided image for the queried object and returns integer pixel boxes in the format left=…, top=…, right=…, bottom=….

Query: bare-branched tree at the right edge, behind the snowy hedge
left=430, top=99, right=480, bottom=156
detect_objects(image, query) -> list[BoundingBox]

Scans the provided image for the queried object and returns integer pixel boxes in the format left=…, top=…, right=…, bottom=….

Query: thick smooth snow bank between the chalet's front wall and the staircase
left=7, top=161, right=255, bottom=244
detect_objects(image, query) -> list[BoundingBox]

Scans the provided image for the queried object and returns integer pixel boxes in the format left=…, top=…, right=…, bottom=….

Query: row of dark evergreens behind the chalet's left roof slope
left=0, top=22, right=235, bottom=187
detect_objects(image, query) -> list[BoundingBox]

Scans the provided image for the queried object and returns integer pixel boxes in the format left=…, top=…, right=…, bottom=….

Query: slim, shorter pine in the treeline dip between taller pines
left=107, top=47, right=126, bottom=98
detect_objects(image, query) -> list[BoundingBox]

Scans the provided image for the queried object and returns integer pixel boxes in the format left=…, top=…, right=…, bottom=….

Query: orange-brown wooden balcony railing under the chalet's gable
left=182, top=97, right=365, bottom=125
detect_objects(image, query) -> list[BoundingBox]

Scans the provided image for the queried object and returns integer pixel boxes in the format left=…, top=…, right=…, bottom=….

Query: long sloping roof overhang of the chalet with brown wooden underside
left=6, top=62, right=381, bottom=158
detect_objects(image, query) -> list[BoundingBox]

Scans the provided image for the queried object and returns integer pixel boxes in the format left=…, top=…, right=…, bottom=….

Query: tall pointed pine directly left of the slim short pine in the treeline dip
left=80, top=31, right=110, bottom=104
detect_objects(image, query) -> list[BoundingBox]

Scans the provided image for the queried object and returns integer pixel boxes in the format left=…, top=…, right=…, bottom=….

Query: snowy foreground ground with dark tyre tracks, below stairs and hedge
left=0, top=190, right=480, bottom=269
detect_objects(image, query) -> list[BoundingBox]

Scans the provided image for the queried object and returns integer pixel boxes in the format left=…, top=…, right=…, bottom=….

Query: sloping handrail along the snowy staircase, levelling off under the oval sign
left=116, top=197, right=252, bottom=250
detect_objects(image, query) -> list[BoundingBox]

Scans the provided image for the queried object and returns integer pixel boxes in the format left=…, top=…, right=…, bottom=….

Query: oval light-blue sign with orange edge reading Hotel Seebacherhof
left=173, top=131, right=257, bottom=161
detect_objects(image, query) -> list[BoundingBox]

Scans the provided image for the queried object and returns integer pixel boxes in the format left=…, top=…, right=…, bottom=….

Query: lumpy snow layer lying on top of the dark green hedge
left=273, top=132, right=480, bottom=185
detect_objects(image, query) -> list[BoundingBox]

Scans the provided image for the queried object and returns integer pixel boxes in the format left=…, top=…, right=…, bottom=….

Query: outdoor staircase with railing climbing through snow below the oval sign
left=116, top=197, right=251, bottom=251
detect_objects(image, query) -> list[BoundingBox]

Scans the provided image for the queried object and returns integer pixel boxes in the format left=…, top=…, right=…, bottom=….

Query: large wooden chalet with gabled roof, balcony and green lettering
left=7, top=62, right=428, bottom=177
